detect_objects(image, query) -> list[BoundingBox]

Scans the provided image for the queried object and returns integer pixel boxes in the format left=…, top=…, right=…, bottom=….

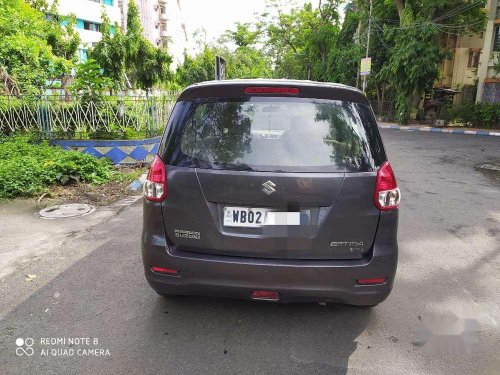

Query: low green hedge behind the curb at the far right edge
left=445, top=103, right=500, bottom=129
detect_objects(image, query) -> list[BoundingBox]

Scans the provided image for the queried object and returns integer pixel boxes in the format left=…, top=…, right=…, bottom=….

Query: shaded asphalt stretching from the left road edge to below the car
left=0, top=235, right=376, bottom=374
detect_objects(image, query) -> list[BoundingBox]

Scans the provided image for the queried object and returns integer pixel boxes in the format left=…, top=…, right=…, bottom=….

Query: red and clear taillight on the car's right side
left=373, top=161, right=401, bottom=211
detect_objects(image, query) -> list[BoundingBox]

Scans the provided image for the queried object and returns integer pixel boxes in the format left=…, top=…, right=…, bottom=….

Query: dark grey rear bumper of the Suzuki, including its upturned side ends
left=142, top=203, right=398, bottom=305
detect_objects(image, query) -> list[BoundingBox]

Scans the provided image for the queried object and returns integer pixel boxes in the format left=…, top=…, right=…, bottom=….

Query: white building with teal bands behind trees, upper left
left=51, top=0, right=121, bottom=61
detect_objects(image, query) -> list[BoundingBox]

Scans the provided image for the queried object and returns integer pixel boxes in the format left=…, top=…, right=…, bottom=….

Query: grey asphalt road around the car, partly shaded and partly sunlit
left=0, top=130, right=500, bottom=375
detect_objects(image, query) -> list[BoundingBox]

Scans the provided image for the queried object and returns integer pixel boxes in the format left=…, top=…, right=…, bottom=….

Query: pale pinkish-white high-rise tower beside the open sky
left=118, top=0, right=168, bottom=47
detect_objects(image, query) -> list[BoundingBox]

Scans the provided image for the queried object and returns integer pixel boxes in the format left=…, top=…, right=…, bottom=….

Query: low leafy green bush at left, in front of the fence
left=0, top=137, right=116, bottom=198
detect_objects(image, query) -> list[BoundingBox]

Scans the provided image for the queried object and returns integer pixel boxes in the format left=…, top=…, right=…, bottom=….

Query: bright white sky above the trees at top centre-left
left=167, top=0, right=318, bottom=65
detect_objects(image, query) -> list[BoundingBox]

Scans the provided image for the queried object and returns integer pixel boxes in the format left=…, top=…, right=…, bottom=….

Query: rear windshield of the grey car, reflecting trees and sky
left=167, top=97, right=385, bottom=172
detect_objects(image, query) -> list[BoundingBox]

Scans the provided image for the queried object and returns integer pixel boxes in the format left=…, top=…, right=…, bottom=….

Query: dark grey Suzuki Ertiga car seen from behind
left=142, top=80, right=400, bottom=306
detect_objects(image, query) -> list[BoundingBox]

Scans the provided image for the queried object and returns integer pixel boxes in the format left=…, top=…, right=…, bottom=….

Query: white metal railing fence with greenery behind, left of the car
left=0, top=92, right=178, bottom=138
